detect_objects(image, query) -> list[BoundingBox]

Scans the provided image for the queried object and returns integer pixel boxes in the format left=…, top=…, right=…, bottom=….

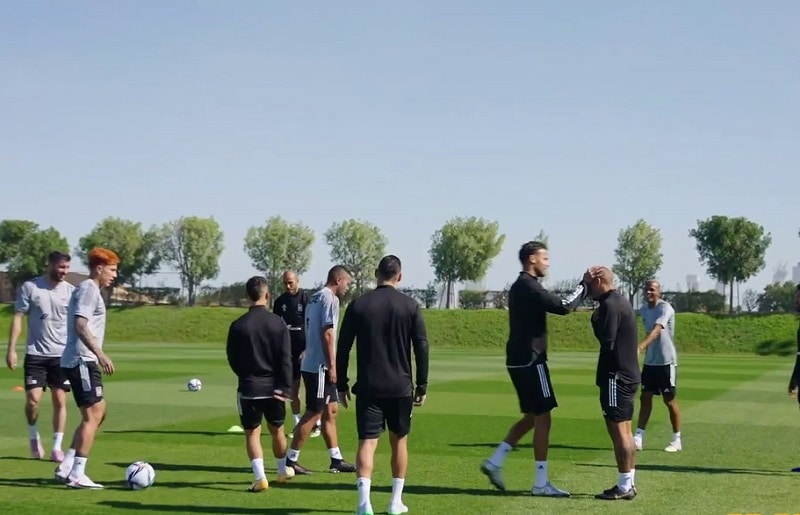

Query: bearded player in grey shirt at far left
left=6, top=251, right=75, bottom=463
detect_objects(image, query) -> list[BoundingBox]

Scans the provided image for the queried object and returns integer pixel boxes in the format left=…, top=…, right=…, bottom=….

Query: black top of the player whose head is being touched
left=592, top=290, right=641, bottom=386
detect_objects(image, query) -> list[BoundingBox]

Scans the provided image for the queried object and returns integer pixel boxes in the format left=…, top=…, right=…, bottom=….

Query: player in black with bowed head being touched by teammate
left=584, top=267, right=641, bottom=501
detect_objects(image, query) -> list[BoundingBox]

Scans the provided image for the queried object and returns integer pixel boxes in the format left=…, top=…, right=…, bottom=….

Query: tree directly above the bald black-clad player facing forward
left=244, top=216, right=314, bottom=299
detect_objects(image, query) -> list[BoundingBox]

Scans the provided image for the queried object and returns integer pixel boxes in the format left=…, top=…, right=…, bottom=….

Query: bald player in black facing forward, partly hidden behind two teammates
left=272, top=270, right=321, bottom=437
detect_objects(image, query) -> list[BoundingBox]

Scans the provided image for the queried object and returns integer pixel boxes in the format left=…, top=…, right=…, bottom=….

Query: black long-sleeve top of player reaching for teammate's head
left=506, top=272, right=586, bottom=367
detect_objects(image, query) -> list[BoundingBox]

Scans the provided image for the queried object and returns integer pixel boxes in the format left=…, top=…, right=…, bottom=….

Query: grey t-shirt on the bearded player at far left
left=14, top=276, right=75, bottom=358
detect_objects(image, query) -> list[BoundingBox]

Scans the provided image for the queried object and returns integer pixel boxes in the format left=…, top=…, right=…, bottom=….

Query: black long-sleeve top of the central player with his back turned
left=336, top=286, right=428, bottom=398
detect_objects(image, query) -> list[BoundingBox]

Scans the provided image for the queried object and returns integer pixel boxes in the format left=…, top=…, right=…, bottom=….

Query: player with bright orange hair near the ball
left=56, top=247, right=120, bottom=489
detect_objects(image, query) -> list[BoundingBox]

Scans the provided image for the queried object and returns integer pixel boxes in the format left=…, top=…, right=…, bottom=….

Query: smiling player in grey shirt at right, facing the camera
left=633, top=280, right=683, bottom=452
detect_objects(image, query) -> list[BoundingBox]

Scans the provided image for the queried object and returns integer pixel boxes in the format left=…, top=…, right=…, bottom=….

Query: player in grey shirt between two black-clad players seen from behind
left=286, top=265, right=356, bottom=474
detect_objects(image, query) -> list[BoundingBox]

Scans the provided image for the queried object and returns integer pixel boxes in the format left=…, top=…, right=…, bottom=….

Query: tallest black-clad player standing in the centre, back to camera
left=336, top=255, right=428, bottom=514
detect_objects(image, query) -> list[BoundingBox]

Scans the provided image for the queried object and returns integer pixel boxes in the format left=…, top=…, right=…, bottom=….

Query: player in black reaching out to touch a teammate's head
left=480, top=241, right=586, bottom=497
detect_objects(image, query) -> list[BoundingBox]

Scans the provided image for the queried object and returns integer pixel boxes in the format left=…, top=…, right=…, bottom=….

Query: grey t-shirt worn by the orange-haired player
left=61, top=279, right=106, bottom=368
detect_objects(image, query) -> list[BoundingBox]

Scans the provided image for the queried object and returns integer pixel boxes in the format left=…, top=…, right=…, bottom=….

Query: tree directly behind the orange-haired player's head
left=75, top=216, right=161, bottom=287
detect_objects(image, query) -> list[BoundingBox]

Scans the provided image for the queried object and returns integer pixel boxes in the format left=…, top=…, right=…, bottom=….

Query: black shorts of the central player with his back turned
left=356, top=395, right=414, bottom=440
